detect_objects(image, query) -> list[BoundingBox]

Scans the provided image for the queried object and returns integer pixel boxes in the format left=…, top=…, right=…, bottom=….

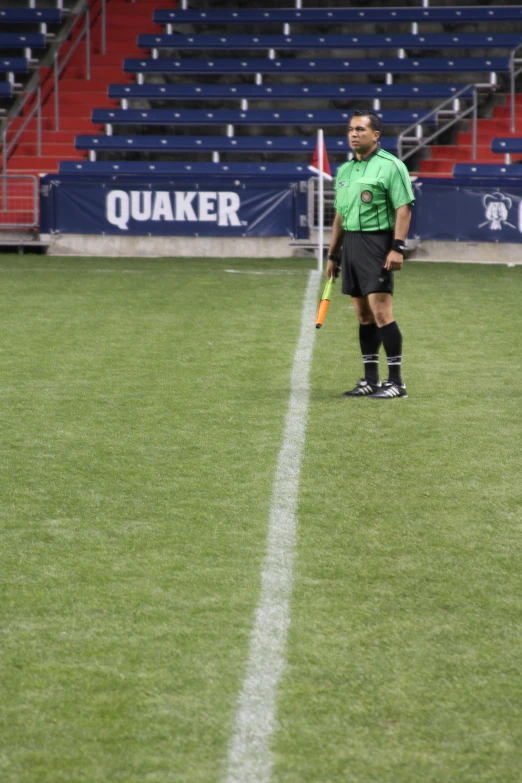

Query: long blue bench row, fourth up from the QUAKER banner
left=108, top=84, right=473, bottom=101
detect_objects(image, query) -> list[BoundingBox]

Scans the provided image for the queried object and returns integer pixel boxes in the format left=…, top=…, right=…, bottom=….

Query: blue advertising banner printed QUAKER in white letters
left=41, top=175, right=298, bottom=237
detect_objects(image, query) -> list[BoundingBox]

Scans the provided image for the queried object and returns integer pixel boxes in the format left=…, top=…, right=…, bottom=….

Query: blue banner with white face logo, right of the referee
left=410, top=178, right=522, bottom=242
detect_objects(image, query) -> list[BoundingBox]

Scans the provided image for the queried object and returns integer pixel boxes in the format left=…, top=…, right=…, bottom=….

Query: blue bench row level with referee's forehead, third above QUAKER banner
left=92, top=109, right=435, bottom=127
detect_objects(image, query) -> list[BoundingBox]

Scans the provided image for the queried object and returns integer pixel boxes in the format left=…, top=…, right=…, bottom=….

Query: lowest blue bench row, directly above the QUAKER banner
left=59, top=160, right=324, bottom=180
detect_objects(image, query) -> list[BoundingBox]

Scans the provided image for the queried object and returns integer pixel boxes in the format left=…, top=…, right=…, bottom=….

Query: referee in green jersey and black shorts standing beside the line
left=326, top=110, right=415, bottom=399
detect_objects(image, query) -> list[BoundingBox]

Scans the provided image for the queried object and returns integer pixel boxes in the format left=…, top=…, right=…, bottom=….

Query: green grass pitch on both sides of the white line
left=0, top=255, right=522, bottom=783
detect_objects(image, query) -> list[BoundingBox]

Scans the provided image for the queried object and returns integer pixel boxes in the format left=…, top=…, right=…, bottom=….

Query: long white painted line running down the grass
left=226, top=271, right=321, bottom=783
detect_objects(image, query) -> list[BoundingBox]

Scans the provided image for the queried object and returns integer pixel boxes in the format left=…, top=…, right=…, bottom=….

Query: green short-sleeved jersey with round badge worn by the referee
left=335, top=147, right=415, bottom=231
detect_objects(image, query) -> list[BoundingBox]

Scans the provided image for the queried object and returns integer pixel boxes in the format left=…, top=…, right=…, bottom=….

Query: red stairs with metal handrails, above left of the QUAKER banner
left=8, top=0, right=158, bottom=175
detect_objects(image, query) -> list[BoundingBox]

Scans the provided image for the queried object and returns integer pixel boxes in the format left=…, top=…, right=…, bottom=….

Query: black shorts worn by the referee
left=342, top=231, right=393, bottom=297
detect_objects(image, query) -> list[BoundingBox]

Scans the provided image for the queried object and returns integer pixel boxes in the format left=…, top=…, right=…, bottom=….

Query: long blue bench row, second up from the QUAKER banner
left=75, top=135, right=397, bottom=155
